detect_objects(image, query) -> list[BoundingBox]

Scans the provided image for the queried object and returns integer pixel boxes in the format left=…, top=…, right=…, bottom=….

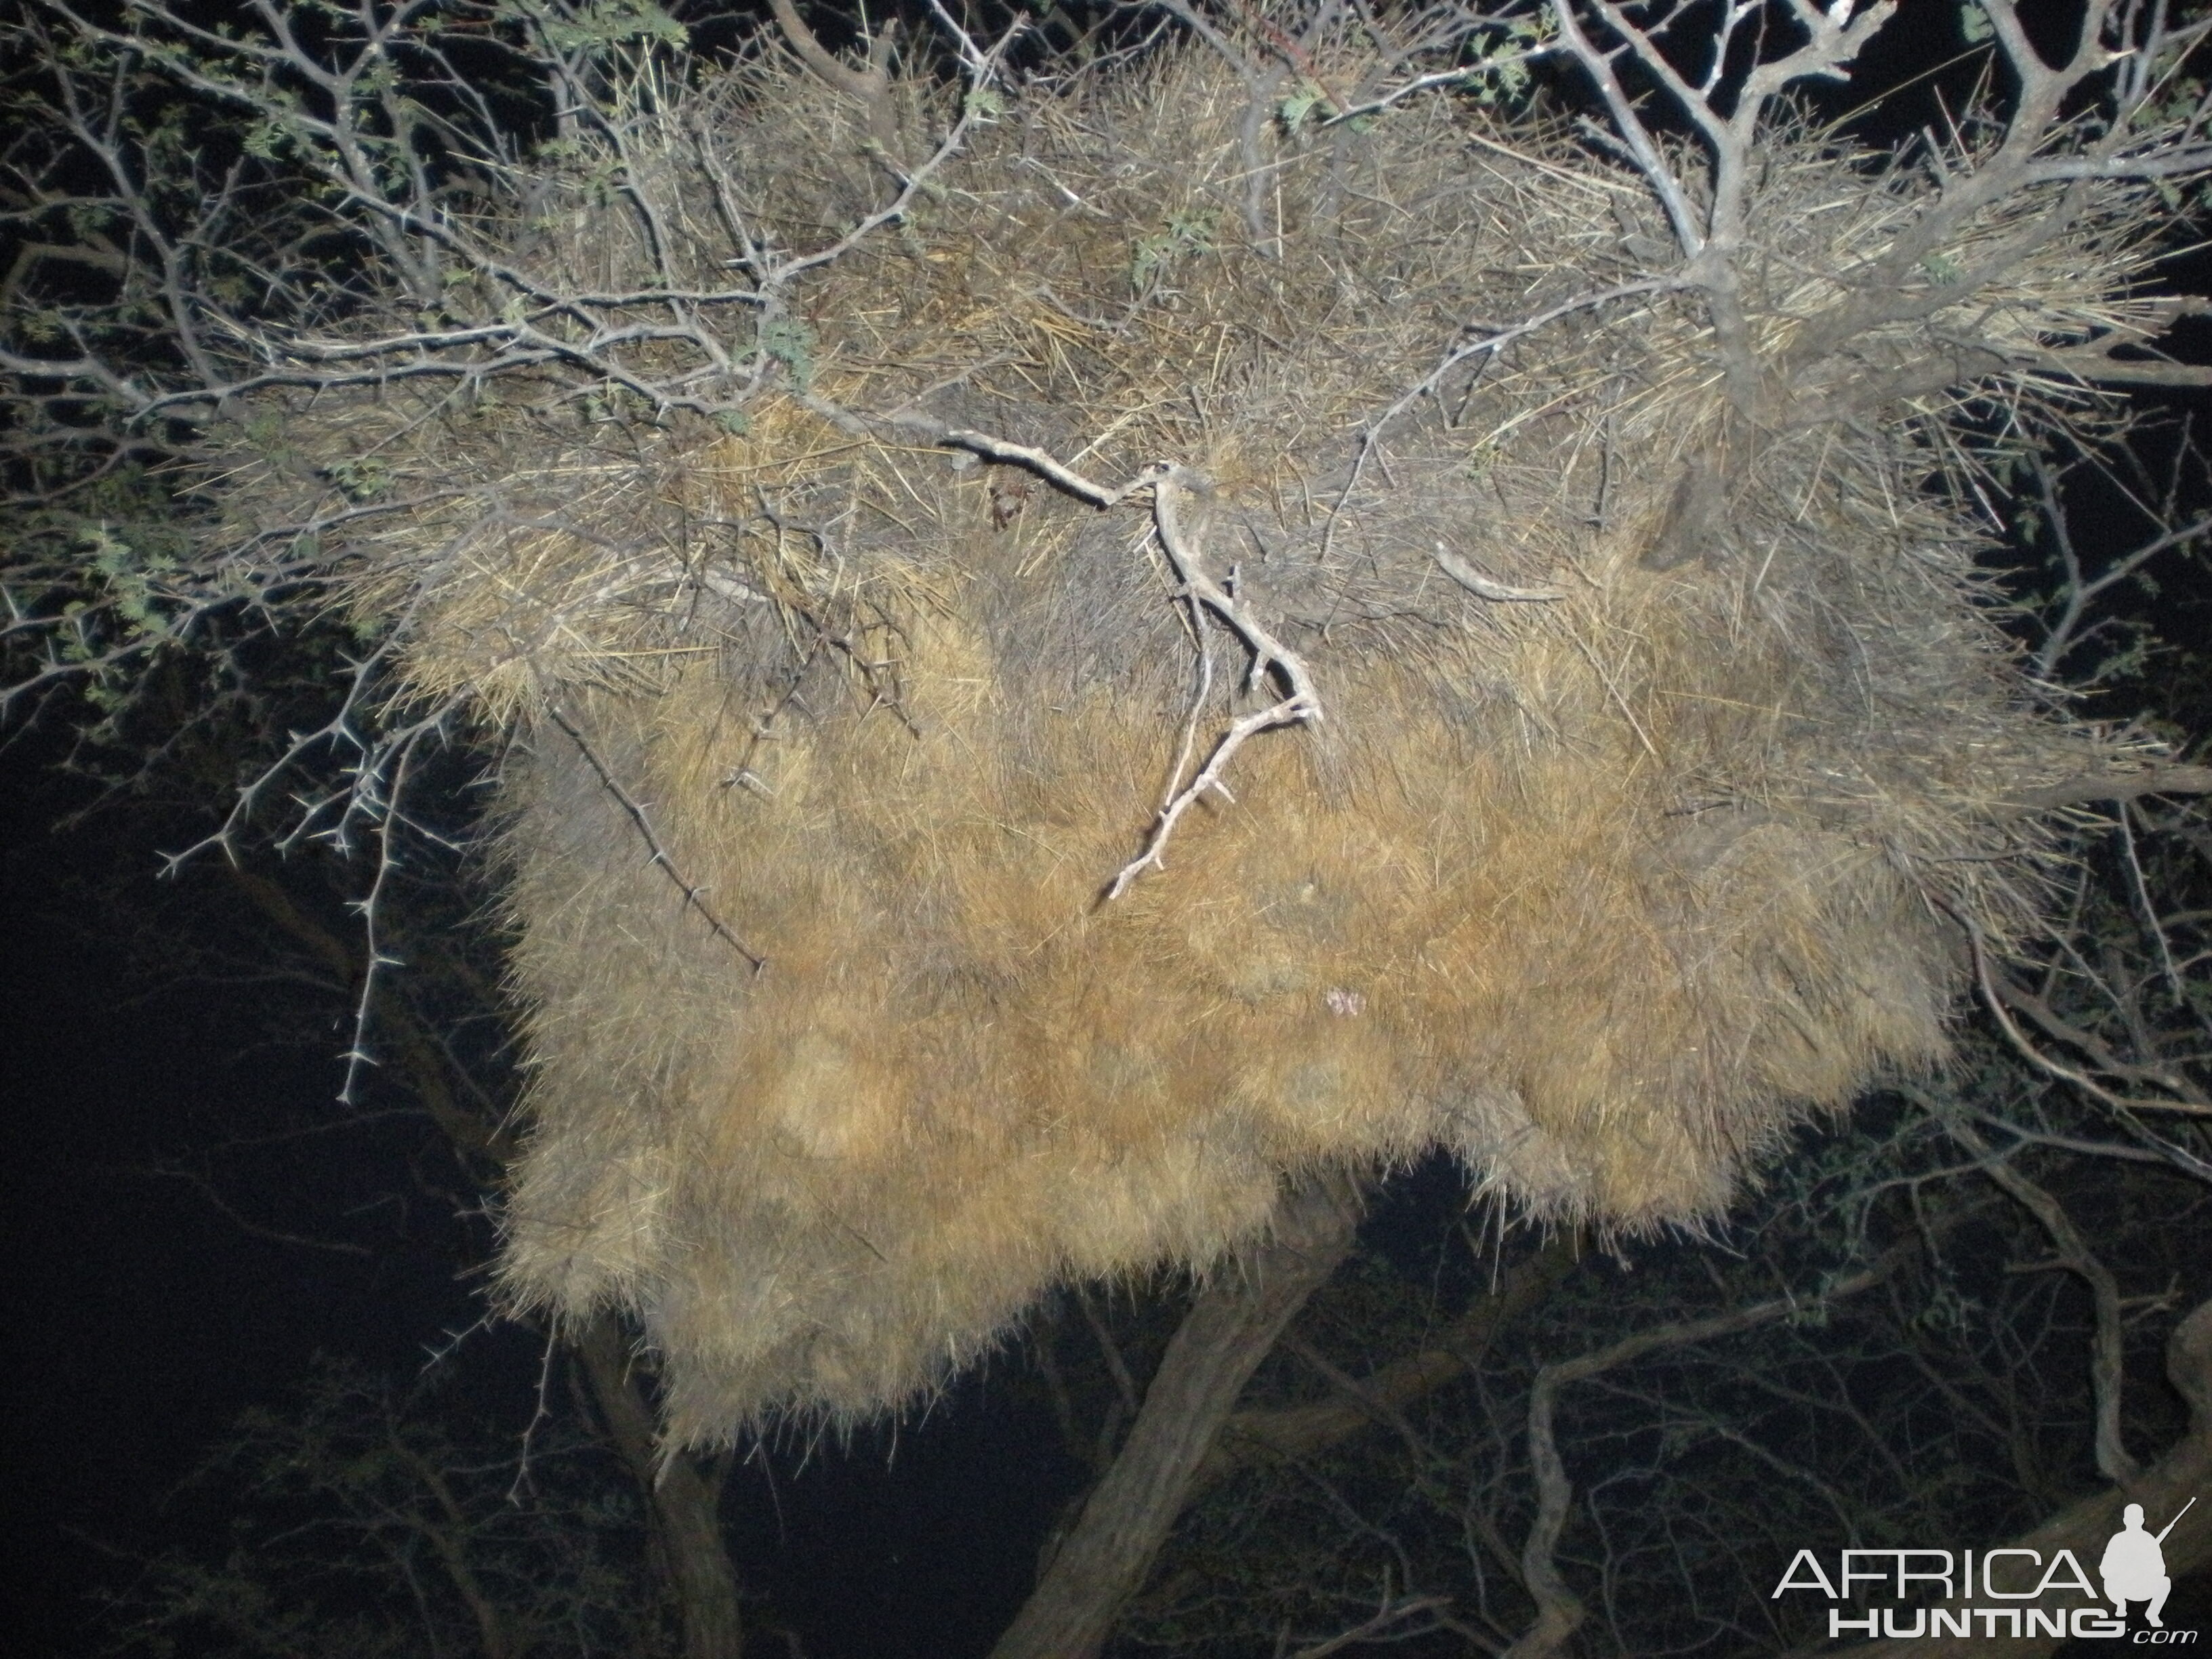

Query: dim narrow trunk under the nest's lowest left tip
left=575, top=1314, right=745, bottom=1659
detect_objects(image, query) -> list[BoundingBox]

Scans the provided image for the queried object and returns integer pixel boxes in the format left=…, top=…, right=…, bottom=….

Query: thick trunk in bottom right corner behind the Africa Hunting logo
left=1841, top=1303, right=2212, bottom=1659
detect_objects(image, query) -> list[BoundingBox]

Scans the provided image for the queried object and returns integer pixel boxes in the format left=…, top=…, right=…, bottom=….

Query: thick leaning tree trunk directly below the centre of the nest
left=991, top=1176, right=1358, bottom=1659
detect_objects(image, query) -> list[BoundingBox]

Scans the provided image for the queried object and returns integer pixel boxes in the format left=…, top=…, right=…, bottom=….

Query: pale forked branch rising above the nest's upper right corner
left=1549, top=0, right=2212, bottom=417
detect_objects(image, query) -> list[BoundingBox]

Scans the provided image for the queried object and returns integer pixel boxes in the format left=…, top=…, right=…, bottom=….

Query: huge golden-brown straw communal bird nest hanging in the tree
left=224, top=35, right=2158, bottom=1442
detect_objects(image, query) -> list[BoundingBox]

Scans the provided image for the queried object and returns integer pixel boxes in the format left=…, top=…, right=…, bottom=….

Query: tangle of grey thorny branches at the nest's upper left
left=0, top=0, right=1020, bottom=1079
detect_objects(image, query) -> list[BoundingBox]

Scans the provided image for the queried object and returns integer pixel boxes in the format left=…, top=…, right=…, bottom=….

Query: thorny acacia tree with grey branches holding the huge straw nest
left=13, top=0, right=2212, bottom=1657
